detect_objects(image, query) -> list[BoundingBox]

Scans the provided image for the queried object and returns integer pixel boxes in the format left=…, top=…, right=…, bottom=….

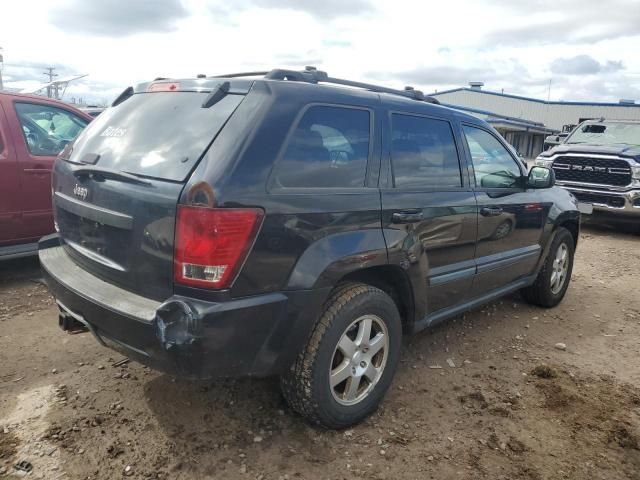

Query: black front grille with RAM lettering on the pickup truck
left=552, top=157, right=631, bottom=187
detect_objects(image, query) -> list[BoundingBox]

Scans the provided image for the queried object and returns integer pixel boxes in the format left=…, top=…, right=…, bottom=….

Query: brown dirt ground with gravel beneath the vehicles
left=0, top=227, right=640, bottom=480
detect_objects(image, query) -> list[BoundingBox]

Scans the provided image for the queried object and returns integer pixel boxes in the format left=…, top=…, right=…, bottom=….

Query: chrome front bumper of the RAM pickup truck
left=563, top=185, right=640, bottom=221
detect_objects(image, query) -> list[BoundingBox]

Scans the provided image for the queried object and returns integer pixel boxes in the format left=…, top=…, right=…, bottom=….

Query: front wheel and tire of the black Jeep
left=521, top=227, right=575, bottom=308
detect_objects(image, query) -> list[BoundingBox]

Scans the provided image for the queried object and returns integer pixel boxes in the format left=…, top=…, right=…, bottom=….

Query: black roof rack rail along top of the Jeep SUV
left=213, top=66, right=440, bottom=105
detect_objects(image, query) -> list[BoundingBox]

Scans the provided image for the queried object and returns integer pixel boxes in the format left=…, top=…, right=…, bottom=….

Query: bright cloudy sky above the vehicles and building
left=0, top=0, right=640, bottom=102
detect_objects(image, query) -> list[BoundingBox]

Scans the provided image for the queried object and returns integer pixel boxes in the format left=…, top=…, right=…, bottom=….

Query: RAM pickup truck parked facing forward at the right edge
left=536, top=120, right=640, bottom=226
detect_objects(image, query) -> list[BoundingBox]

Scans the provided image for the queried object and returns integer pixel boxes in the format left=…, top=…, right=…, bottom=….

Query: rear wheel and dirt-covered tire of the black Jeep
left=280, top=283, right=402, bottom=429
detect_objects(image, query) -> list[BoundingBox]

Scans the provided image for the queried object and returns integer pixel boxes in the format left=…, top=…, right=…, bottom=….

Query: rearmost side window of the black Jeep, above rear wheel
left=274, top=105, right=371, bottom=188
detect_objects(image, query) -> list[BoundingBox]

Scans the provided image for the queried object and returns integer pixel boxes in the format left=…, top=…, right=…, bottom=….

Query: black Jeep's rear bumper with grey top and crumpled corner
left=39, top=235, right=329, bottom=379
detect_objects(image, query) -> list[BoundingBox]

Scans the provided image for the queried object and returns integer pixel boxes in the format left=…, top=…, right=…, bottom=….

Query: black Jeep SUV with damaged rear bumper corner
left=39, top=68, right=580, bottom=428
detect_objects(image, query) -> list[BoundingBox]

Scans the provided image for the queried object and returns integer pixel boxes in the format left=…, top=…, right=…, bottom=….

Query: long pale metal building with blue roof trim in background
left=431, top=82, right=640, bottom=158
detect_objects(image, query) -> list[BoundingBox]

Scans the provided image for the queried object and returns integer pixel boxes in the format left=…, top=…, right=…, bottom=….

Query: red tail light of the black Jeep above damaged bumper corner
left=174, top=205, right=263, bottom=289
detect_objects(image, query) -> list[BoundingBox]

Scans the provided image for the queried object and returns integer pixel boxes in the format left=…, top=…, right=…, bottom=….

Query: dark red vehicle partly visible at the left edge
left=0, top=92, right=92, bottom=260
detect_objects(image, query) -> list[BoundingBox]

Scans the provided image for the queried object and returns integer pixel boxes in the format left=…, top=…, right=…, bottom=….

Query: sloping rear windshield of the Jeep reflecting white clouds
left=67, top=92, right=244, bottom=181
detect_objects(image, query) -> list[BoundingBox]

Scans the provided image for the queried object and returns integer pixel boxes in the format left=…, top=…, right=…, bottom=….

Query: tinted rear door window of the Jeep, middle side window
left=391, top=114, right=462, bottom=189
